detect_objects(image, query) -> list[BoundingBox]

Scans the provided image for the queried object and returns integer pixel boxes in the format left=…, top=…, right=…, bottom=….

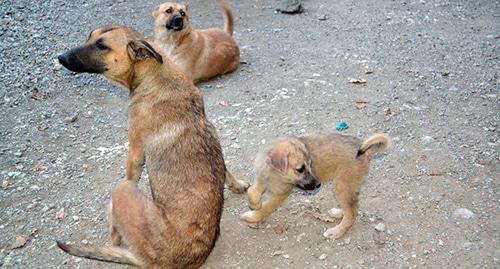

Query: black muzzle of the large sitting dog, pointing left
left=57, top=47, right=106, bottom=74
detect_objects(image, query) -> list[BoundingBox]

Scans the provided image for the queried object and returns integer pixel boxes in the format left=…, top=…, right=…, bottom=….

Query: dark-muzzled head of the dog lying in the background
left=153, top=3, right=189, bottom=32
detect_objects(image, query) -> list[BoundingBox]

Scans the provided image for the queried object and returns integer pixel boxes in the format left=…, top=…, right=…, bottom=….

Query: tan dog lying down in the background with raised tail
left=153, top=2, right=240, bottom=81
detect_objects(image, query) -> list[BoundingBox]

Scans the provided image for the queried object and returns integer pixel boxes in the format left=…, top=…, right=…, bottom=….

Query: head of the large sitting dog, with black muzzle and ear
left=57, top=27, right=162, bottom=87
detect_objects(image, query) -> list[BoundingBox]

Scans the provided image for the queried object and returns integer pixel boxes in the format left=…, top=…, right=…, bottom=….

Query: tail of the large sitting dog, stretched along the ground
left=56, top=241, right=145, bottom=267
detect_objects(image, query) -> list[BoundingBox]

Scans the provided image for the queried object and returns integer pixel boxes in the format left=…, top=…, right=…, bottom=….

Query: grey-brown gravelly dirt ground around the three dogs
left=0, top=0, right=500, bottom=269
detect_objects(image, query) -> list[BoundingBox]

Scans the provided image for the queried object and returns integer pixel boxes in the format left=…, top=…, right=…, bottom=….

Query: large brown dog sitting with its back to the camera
left=58, top=27, right=247, bottom=268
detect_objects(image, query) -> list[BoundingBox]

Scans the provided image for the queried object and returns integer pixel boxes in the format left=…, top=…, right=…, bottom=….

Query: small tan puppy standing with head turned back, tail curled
left=241, top=134, right=389, bottom=239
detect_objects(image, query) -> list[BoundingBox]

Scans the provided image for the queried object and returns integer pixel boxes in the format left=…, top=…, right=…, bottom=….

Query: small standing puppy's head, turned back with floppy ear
left=266, top=138, right=321, bottom=193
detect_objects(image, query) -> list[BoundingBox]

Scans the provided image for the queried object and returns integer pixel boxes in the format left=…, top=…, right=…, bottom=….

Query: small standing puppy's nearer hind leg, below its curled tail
left=323, top=180, right=359, bottom=240
